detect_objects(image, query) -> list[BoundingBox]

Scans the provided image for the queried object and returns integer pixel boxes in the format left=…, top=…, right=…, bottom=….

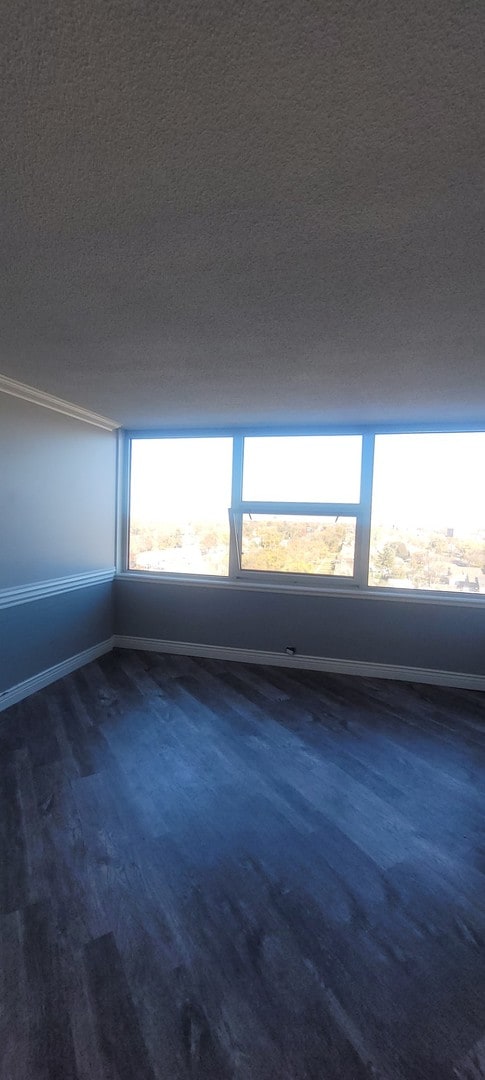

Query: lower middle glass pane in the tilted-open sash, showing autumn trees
left=241, top=514, right=355, bottom=577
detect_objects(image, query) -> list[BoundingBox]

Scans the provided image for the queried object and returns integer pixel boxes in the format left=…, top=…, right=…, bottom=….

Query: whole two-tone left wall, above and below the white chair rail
left=0, top=392, right=116, bottom=691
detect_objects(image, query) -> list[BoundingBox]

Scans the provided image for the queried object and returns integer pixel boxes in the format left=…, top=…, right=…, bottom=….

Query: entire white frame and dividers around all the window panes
left=117, top=421, right=485, bottom=606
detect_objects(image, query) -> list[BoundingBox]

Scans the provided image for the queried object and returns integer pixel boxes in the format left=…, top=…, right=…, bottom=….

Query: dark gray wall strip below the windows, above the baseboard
left=114, top=578, right=485, bottom=675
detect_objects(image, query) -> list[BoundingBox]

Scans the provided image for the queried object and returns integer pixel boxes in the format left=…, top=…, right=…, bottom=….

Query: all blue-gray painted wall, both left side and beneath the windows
left=0, top=393, right=485, bottom=692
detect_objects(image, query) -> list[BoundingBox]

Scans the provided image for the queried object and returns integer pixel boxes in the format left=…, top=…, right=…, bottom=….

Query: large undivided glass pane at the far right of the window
left=368, top=432, right=485, bottom=593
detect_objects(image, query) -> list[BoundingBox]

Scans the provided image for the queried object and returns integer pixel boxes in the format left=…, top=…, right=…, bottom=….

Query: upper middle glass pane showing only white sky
left=243, top=435, right=362, bottom=502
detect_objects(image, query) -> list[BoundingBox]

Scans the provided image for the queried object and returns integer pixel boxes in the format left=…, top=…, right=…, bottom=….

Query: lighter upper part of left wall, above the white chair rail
left=0, top=393, right=116, bottom=589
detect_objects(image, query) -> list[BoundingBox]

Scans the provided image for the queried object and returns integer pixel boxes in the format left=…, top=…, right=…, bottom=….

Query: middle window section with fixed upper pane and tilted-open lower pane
left=232, top=435, right=362, bottom=581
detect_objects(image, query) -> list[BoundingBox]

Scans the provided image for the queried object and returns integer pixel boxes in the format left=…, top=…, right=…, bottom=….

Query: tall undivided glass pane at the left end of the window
left=129, top=438, right=232, bottom=575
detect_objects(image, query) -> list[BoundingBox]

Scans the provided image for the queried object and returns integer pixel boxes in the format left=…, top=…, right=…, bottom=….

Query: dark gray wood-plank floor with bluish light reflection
left=0, top=651, right=485, bottom=1080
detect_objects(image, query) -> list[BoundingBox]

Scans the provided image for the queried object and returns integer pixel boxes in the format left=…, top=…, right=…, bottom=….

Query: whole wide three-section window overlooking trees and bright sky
left=127, top=431, right=485, bottom=595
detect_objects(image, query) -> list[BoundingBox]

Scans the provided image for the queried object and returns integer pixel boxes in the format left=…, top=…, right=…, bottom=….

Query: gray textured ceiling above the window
left=0, top=0, right=485, bottom=427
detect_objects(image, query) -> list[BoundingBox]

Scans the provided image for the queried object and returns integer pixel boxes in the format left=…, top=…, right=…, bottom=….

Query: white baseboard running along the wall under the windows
left=113, top=634, right=485, bottom=690
